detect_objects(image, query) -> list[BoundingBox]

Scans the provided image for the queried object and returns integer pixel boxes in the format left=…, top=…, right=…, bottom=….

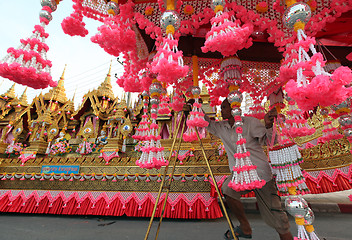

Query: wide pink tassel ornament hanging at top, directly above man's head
left=202, top=1, right=253, bottom=56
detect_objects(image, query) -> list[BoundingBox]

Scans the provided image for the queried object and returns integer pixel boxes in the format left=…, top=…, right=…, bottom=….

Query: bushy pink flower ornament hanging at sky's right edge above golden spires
left=91, top=1, right=136, bottom=57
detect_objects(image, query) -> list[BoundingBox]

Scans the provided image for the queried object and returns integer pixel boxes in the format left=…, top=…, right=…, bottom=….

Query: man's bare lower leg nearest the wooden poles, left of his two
left=225, top=195, right=252, bottom=235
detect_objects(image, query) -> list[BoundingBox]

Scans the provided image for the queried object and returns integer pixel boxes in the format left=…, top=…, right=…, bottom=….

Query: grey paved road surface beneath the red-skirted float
left=0, top=213, right=352, bottom=240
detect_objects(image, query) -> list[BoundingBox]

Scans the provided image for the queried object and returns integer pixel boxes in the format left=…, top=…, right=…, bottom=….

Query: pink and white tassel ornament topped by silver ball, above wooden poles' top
left=151, top=10, right=189, bottom=84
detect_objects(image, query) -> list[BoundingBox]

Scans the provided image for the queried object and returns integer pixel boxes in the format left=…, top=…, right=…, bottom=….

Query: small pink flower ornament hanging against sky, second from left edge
left=61, top=0, right=88, bottom=37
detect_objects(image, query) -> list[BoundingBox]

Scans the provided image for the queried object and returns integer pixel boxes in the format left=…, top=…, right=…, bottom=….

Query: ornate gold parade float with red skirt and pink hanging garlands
left=0, top=0, right=352, bottom=236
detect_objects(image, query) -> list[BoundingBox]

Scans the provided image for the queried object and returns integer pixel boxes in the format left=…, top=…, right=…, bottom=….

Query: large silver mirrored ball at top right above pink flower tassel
left=282, top=2, right=312, bottom=28
